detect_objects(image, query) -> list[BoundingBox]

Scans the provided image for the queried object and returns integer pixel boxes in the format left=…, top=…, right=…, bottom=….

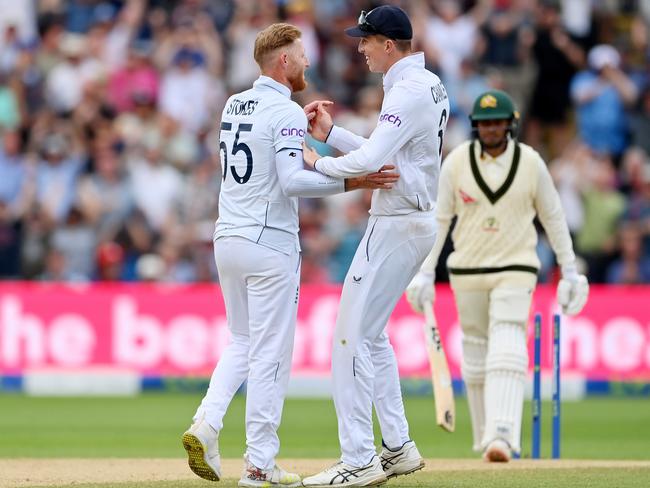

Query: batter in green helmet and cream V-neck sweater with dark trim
left=406, top=90, right=589, bottom=462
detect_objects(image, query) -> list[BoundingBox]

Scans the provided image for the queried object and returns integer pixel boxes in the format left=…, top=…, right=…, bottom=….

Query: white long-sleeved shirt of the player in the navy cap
left=315, top=53, right=449, bottom=215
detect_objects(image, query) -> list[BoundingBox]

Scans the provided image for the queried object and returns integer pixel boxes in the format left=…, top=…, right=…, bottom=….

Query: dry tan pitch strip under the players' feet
left=0, top=459, right=650, bottom=488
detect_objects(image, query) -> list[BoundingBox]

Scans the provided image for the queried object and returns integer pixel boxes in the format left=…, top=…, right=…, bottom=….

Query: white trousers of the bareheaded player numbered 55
left=195, top=237, right=300, bottom=469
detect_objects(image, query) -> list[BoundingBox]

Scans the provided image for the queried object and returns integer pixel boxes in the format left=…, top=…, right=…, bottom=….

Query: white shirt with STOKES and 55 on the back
left=214, top=76, right=345, bottom=253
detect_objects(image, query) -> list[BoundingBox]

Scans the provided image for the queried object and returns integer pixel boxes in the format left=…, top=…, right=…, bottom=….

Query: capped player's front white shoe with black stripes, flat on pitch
left=302, top=456, right=388, bottom=488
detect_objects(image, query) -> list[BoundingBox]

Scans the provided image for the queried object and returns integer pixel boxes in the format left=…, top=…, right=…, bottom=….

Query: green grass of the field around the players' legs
left=0, top=393, right=650, bottom=488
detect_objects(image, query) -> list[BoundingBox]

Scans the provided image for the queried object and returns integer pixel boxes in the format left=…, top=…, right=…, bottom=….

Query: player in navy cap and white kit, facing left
left=303, top=6, right=449, bottom=486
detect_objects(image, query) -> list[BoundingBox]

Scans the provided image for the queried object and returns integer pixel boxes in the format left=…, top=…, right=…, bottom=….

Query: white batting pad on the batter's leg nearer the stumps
left=482, top=322, right=528, bottom=452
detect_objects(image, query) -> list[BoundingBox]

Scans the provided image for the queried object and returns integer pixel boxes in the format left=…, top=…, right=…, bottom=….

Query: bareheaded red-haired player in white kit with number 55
left=183, top=24, right=398, bottom=487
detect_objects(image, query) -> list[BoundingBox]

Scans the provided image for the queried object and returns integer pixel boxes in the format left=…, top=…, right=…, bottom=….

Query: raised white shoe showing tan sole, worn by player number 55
left=183, top=414, right=221, bottom=481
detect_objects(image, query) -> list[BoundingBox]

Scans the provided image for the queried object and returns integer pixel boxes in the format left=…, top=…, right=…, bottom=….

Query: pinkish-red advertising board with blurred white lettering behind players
left=0, top=283, right=650, bottom=380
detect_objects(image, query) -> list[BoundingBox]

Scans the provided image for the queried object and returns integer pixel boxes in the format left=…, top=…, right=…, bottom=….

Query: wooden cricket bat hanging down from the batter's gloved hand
left=424, top=303, right=456, bottom=432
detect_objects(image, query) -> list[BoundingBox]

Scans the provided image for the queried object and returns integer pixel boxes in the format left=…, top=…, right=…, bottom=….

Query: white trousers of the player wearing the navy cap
left=332, top=212, right=436, bottom=467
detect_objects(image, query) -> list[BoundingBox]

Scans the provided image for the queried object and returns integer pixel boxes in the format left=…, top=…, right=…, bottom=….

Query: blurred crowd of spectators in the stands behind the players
left=0, top=0, right=650, bottom=283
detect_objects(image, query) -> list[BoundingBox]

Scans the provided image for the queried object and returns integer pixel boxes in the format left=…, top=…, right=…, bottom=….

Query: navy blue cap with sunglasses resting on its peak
left=345, top=5, right=413, bottom=40
